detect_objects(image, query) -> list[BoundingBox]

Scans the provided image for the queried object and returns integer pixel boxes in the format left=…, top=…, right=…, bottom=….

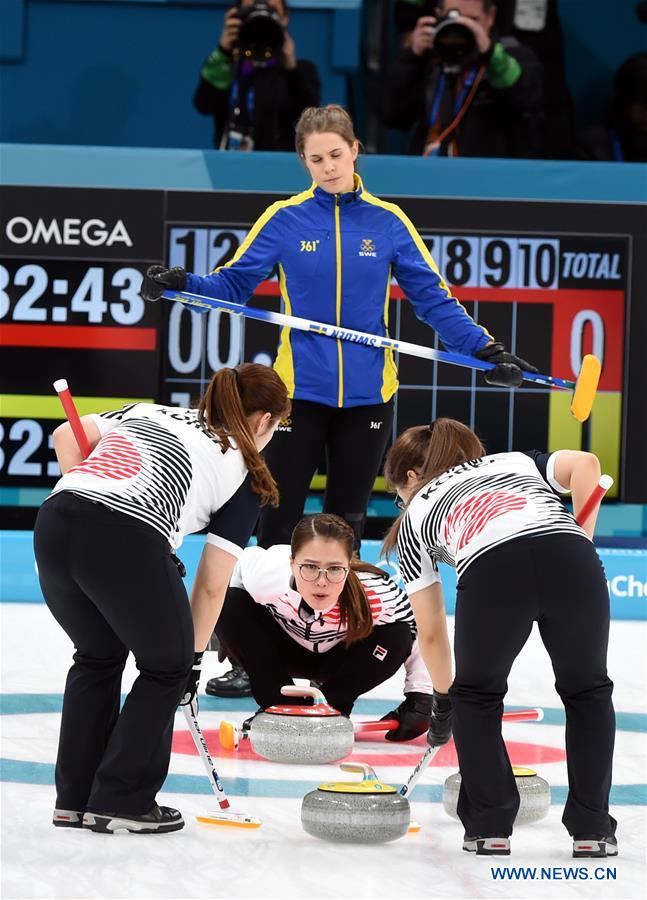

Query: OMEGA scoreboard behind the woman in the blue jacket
left=0, top=187, right=644, bottom=527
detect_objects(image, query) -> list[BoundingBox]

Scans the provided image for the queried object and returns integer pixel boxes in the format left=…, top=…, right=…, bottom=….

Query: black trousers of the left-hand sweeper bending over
left=34, top=492, right=193, bottom=815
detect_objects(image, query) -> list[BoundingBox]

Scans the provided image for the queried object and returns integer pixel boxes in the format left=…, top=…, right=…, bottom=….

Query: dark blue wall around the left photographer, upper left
left=0, top=0, right=357, bottom=147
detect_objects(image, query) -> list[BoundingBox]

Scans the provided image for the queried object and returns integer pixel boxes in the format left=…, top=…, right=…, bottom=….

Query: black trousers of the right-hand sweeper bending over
left=449, top=534, right=616, bottom=836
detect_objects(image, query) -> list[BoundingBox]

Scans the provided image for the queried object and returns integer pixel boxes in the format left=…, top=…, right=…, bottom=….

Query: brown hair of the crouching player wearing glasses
left=290, top=513, right=388, bottom=647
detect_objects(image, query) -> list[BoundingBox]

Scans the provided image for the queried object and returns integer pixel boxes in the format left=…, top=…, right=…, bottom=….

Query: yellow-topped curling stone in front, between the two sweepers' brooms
left=301, top=763, right=411, bottom=844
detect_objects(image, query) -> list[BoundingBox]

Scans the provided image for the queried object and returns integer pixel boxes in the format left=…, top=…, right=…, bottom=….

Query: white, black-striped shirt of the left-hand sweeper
left=52, top=403, right=259, bottom=556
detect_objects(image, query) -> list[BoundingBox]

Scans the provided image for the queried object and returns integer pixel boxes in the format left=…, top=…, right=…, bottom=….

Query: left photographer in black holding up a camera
left=193, top=0, right=321, bottom=150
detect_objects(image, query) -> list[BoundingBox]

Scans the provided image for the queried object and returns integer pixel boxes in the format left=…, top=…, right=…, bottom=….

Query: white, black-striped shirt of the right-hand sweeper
left=398, top=451, right=586, bottom=593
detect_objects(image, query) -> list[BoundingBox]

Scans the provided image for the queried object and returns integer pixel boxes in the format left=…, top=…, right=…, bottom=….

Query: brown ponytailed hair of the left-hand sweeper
left=198, top=363, right=291, bottom=506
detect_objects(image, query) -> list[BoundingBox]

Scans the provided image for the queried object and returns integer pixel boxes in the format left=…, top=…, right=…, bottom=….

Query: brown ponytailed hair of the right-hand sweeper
left=382, top=419, right=485, bottom=556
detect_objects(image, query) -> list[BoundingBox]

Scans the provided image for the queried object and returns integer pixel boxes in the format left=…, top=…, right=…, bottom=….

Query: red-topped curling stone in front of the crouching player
left=249, top=684, right=355, bottom=764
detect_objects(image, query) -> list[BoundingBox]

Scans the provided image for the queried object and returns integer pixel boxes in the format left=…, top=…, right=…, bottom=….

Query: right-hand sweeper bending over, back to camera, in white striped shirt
left=384, top=419, right=618, bottom=857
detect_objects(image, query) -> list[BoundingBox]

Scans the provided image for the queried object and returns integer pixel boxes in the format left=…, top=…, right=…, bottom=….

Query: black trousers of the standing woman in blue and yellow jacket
left=258, top=400, right=393, bottom=547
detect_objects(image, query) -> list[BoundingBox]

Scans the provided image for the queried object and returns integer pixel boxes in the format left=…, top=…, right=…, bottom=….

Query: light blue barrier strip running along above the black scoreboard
left=0, top=143, right=647, bottom=203
